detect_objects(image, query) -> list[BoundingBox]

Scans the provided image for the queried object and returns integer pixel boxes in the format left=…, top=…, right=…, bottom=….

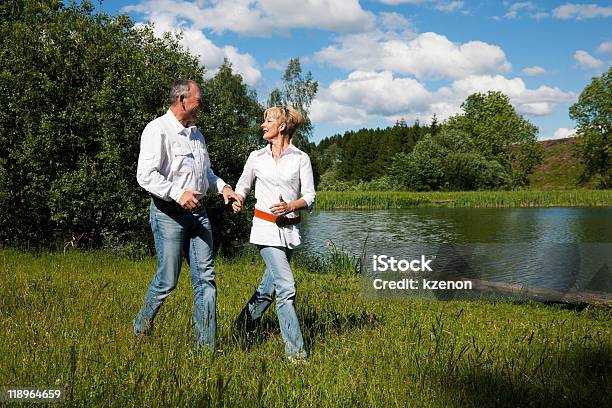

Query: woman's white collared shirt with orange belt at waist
left=234, top=144, right=315, bottom=248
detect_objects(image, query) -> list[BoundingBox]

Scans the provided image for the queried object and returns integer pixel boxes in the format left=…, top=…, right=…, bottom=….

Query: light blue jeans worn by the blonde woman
left=247, top=246, right=306, bottom=357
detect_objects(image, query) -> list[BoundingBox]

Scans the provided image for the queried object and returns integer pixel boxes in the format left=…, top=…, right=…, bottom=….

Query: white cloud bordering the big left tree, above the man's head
left=142, top=16, right=261, bottom=85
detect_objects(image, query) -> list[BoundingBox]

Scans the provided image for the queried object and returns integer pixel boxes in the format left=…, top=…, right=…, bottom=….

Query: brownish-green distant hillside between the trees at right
left=529, top=137, right=589, bottom=190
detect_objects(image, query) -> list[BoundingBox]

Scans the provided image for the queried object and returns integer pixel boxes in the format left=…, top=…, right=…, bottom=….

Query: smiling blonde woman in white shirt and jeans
left=233, top=107, right=315, bottom=363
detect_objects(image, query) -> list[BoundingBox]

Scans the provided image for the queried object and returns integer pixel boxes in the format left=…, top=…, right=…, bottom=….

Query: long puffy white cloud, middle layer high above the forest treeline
left=315, top=32, right=511, bottom=79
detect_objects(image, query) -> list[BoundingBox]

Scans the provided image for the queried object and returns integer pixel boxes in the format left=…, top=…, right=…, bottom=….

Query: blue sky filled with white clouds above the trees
left=92, top=0, right=612, bottom=142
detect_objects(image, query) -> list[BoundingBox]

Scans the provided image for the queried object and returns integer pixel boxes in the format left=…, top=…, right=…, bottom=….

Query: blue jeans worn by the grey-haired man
left=134, top=203, right=217, bottom=350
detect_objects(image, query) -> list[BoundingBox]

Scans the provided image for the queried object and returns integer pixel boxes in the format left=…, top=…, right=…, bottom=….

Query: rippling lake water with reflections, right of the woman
left=303, top=208, right=612, bottom=290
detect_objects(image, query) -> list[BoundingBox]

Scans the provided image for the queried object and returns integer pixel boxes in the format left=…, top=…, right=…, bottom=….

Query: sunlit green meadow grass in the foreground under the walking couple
left=0, top=250, right=612, bottom=407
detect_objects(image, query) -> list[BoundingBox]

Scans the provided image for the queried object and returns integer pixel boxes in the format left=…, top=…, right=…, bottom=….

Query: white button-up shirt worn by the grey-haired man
left=136, top=110, right=226, bottom=203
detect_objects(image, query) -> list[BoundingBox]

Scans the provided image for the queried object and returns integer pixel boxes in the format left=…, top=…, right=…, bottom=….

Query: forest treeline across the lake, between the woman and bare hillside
left=310, top=91, right=543, bottom=191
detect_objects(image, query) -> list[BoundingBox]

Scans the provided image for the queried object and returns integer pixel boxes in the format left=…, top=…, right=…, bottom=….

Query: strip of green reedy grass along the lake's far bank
left=316, top=190, right=612, bottom=210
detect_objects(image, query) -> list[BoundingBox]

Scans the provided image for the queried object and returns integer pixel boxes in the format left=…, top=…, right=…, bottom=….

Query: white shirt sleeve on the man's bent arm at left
left=136, top=124, right=184, bottom=202
